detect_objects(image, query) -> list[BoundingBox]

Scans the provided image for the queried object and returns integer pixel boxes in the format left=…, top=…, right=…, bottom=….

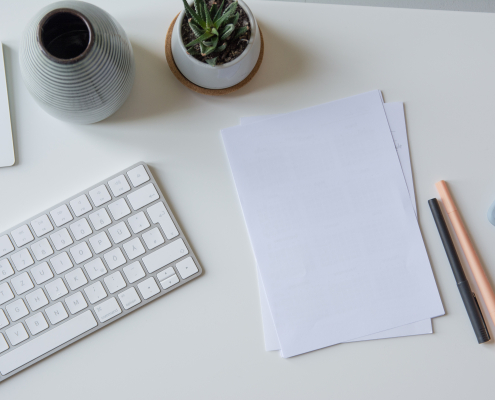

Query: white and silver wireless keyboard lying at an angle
left=0, top=163, right=202, bottom=382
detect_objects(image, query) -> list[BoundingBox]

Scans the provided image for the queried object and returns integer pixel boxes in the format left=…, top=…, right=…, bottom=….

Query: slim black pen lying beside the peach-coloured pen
left=428, top=199, right=490, bottom=343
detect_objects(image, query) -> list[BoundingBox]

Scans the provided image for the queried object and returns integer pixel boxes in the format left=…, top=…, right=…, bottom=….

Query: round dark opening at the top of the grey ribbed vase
left=38, top=9, right=93, bottom=62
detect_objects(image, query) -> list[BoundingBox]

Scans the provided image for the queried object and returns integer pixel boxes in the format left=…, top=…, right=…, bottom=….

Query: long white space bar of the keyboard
left=0, top=311, right=97, bottom=375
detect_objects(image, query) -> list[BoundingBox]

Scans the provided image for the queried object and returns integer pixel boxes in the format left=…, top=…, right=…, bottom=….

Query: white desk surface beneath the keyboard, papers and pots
left=0, top=0, right=495, bottom=400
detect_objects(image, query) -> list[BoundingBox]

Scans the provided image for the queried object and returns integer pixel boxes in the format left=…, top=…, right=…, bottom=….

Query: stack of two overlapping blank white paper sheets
left=222, top=91, right=444, bottom=357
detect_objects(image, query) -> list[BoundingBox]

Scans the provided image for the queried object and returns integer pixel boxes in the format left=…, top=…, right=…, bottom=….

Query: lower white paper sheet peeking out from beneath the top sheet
left=241, top=102, right=433, bottom=351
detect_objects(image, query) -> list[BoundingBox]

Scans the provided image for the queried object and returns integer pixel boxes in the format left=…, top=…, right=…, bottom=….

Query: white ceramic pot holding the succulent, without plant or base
left=172, top=0, right=261, bottom=89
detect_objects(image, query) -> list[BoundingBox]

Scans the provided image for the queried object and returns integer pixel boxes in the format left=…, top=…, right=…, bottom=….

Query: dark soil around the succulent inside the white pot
left=181, top=0, right=251, bottom=65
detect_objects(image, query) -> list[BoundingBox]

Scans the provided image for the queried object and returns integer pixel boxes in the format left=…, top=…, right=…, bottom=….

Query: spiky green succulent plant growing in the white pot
left=182, top=0, right=249, bottom=66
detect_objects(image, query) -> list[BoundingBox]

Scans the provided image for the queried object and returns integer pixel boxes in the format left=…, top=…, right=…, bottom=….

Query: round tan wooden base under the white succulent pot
left=165, top=14, right=265, bottom=96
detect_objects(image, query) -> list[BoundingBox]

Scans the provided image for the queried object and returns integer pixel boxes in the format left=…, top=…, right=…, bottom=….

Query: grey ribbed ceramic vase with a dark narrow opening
left=19, top=1, right=135, bottom=124
